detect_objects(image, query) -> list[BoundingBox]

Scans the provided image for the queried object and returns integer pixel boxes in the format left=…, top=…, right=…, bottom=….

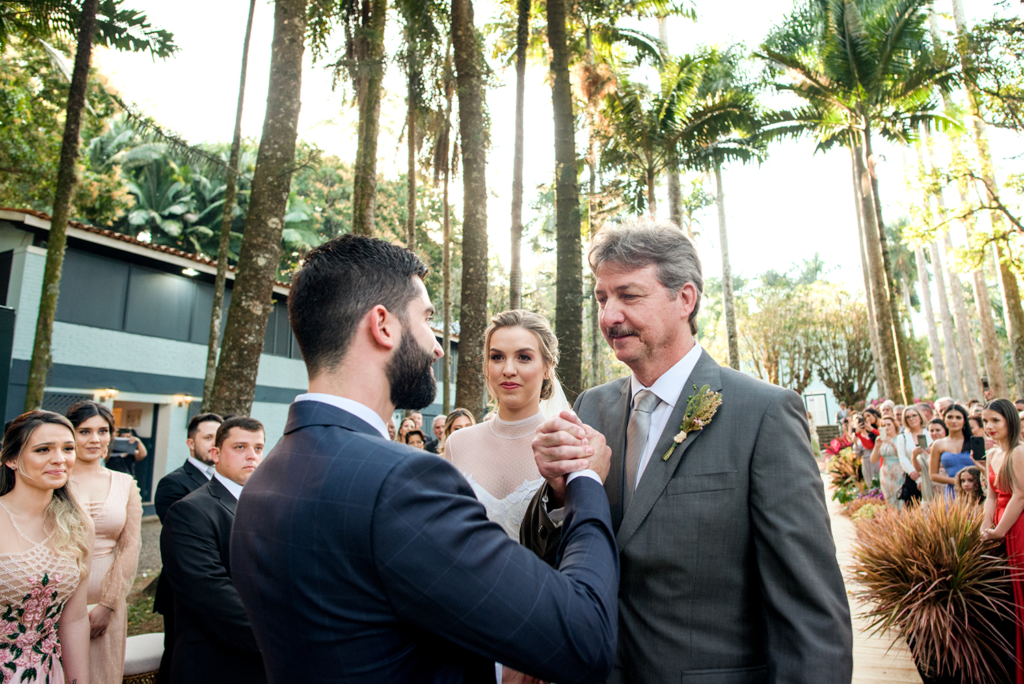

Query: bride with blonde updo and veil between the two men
left=444, top=309, right=569, bottom=542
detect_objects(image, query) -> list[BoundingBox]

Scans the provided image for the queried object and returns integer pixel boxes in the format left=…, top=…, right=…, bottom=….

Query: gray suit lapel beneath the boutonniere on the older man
left=615, top=351, right=722, bottom=549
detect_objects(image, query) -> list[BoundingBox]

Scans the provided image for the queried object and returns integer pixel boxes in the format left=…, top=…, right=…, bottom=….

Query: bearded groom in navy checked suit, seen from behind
left=231, top=236, right=618, bottom=684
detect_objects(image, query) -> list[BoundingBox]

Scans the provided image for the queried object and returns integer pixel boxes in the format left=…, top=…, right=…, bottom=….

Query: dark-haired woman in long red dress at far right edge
left=981, top=399, right=1024, bottom=684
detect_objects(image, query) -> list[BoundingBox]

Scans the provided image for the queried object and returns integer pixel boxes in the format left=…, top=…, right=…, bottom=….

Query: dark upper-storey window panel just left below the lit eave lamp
left=125, top=266, right=196, bottom=342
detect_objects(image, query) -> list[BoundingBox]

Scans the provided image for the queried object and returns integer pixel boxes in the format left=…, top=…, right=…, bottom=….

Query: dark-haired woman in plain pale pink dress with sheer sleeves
left=68, top=401, right=142, bottom=684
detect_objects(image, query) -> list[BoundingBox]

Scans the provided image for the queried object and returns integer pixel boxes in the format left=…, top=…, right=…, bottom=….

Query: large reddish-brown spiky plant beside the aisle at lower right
left=851, top=500, right=1017, bottom=682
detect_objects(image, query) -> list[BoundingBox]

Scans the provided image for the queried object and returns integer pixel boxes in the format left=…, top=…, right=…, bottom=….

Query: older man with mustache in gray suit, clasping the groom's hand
left=521, top=219, right=853, bottom=684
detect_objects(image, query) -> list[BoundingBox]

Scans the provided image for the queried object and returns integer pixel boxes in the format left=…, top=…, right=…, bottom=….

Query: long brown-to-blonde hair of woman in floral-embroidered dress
left=0, top=411, right=92, bottom=581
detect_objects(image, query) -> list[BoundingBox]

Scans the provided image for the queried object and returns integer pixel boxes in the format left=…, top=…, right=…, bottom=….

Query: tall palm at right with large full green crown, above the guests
left=760, top=0, right=955, bottom=402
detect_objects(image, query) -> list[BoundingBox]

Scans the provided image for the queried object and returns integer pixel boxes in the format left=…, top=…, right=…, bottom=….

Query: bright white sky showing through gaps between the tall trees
left=97, top=0, right=1022, bottom=298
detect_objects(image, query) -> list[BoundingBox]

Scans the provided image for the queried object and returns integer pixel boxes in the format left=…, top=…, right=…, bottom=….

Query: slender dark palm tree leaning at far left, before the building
left=24, top=0, right=177, bottom=411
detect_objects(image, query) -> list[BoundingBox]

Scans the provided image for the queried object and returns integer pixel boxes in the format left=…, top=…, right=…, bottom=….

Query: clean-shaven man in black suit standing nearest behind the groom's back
left=160, top=417, right=265, bottom=684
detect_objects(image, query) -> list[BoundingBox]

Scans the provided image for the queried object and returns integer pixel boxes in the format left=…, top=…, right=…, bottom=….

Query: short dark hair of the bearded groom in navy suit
left=288, top=234, right=427, bottom=378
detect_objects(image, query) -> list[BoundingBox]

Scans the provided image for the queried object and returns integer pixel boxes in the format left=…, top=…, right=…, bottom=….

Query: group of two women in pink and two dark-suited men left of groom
left=0, top=401, right=264, bottom=684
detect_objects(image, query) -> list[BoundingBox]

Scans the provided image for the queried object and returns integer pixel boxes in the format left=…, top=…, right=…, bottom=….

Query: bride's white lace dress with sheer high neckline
left=444, top=412, right=544, bottom=542
